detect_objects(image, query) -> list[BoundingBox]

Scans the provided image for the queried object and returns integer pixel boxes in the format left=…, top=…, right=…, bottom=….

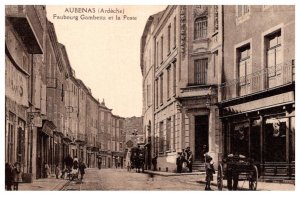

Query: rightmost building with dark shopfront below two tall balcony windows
left=219, top=5, right=295, bottom=179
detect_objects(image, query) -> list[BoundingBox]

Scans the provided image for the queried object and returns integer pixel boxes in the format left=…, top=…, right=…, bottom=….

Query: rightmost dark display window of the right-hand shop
left=264, top=118, right=287, bottom=162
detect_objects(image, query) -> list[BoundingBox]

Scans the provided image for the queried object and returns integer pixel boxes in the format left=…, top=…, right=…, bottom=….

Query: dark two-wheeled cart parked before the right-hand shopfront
left=217, top=154, right=259, bottom=190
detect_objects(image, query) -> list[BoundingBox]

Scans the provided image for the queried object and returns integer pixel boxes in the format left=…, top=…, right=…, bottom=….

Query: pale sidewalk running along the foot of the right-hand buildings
left=145, top=170, right=295, bottom=191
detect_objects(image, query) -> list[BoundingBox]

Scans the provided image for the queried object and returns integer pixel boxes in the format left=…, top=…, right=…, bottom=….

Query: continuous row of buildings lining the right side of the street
left=141, top=5, right=295, bottom=179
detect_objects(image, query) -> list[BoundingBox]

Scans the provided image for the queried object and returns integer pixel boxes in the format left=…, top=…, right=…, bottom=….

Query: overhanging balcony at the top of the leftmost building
left=5, top=5, right=43, bottom=54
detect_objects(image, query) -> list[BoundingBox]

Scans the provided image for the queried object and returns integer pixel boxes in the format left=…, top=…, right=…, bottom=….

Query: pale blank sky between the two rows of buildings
left=46, top=5, right=166, bottom=117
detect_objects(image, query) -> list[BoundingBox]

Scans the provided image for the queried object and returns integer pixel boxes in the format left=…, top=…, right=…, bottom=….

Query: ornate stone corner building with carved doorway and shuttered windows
left=141, top=5, right=222, bottom=170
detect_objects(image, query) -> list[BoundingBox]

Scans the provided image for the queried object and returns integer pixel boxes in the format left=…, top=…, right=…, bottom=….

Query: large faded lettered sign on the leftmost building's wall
left=5, top=58, right=28, bottom=107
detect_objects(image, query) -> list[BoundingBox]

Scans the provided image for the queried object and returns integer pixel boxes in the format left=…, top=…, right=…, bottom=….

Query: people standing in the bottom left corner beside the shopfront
left=5, top=162, right=22, bottom=190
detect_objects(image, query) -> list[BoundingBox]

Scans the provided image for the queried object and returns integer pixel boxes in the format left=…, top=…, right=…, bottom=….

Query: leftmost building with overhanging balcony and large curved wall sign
left=5, top=5, right=46, bottom=180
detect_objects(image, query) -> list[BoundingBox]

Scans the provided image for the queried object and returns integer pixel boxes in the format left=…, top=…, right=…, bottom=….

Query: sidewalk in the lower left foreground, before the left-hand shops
left=19, top=176, right=69, bottom=191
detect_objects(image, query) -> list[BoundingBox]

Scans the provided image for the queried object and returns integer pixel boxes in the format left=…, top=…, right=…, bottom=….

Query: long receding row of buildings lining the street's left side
left=5, top=5, right=125, bottom=182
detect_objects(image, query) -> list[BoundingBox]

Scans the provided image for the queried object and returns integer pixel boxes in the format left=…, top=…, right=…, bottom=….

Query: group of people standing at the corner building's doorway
left=176, top=147, right=193, bottom=173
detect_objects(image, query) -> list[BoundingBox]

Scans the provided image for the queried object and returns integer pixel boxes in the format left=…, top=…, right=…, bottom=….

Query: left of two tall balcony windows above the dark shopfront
left=238, top=45, right=252, bottom=96
